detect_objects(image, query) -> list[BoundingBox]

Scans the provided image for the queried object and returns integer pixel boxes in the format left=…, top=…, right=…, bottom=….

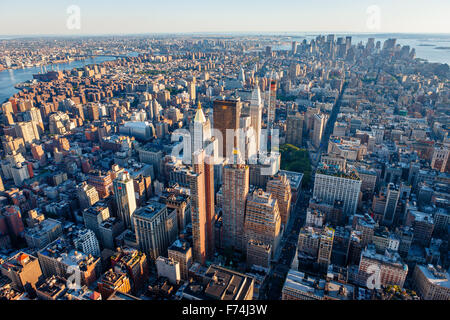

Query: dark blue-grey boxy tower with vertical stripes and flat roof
left=133, top=201, right=169, bottom=261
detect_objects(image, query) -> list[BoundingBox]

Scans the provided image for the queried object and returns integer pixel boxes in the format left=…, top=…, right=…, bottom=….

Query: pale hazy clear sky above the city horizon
left=0, top=0, right=450, bottom=35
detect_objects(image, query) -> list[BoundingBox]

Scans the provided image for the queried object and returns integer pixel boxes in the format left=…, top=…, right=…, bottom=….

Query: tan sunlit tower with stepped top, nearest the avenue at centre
left=244, top=189, right=281, bottom=255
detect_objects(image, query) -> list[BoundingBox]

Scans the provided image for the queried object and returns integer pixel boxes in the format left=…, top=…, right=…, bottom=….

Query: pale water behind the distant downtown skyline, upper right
left=274, top=34, right=450, bottom=65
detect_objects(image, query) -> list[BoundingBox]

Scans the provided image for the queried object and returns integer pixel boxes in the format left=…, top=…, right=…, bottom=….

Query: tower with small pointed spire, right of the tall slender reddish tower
left=222, top=150, right=249, bottom=251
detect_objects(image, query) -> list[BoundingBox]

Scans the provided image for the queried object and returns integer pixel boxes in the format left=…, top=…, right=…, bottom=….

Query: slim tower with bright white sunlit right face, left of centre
left=113, top=171, right=136, bottom=228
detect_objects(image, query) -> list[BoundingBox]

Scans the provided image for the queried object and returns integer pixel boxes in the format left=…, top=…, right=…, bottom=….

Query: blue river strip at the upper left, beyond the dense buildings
left=0, top=57, right=115, bottom=103
